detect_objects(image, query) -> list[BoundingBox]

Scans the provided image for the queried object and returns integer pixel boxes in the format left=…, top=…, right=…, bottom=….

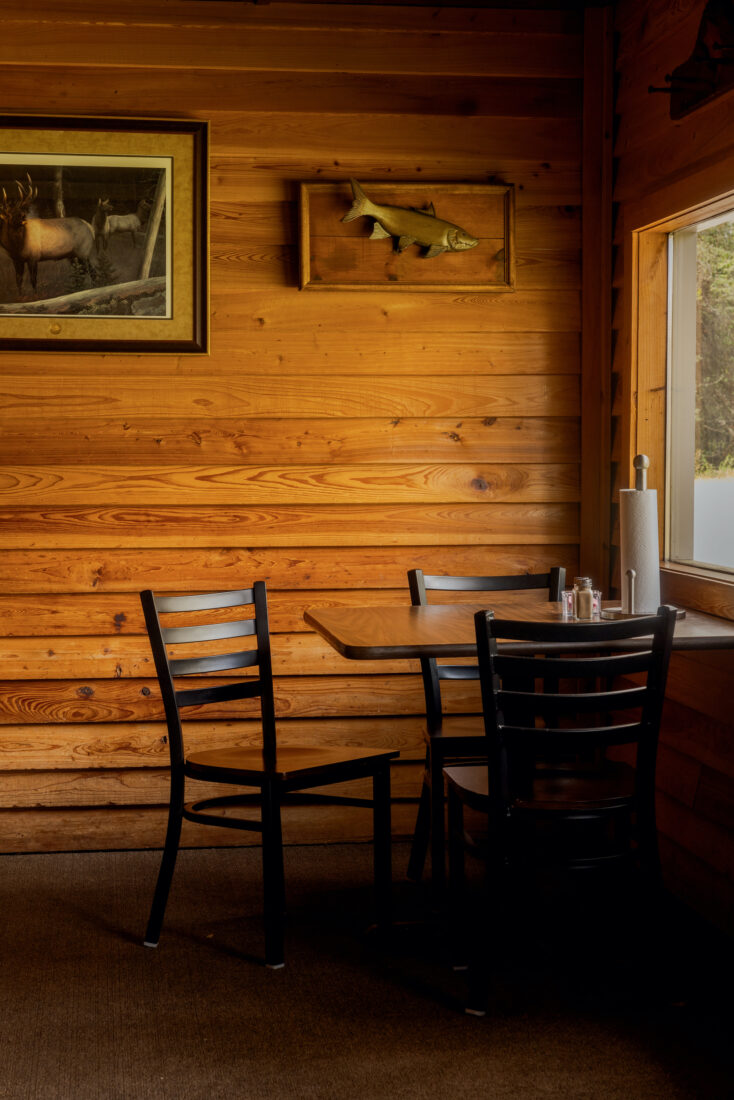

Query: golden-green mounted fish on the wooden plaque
left=341, top=179, right=479, bottom=260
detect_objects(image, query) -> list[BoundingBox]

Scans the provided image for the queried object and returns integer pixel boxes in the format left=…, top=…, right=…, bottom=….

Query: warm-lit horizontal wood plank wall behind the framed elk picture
left=0, top=0, right=583, bottom=851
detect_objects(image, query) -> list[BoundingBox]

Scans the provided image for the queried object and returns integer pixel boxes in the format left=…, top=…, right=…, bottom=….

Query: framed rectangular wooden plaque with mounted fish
left=300, top=179, right=515, bottom=292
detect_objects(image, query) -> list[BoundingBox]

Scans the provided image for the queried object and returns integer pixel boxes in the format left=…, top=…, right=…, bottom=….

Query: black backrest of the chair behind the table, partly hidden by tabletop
left=408, top=565, right=566, bottom=730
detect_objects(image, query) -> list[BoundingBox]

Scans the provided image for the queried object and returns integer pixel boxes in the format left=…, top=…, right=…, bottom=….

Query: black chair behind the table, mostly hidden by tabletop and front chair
left=408, top=567, right=566, bottom=893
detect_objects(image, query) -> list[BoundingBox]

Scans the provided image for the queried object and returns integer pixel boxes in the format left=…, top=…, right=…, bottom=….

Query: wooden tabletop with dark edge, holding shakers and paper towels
left=304, top=593, right=734, bottom=661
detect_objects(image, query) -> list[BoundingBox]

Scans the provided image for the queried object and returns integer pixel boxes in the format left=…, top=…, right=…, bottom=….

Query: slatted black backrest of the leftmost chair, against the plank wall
left=140, top=581, right=275, bottom=767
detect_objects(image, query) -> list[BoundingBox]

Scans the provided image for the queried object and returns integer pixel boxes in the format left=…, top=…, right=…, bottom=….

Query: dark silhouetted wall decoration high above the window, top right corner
left=647, top=0, right=734, bottom=120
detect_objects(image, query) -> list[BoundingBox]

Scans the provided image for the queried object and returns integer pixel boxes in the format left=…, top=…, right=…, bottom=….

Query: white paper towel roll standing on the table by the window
left=620, top=488, right=660, bottom=615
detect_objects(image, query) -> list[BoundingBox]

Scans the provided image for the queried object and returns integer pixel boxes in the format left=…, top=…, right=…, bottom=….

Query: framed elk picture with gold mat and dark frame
left=0, top=116, right=208, bottom=354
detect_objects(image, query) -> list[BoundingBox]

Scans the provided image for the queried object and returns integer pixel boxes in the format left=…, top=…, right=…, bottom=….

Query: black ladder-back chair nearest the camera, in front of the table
left=445, top=607, right=676, bottom=1015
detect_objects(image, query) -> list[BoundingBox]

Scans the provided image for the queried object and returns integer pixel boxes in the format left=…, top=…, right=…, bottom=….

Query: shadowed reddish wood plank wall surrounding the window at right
left=612, top=0, right=734, bottom=928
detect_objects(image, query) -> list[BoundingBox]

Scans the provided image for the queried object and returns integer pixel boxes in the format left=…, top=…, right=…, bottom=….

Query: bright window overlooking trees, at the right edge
left=666, top=209, right=734, bottom=573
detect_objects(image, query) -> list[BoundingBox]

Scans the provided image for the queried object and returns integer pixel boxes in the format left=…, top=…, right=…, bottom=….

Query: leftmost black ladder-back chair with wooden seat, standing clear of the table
left=141, top=581, right=399, bottom=968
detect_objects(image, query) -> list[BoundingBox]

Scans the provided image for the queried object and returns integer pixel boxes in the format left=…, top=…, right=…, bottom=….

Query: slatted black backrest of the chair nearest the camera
left=474, top=606, right=676, bottom=820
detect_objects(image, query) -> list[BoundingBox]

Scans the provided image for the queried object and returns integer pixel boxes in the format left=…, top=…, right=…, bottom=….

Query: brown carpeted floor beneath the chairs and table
left=0, top=845, right=734, bottom=1100
